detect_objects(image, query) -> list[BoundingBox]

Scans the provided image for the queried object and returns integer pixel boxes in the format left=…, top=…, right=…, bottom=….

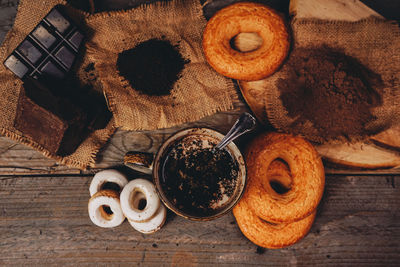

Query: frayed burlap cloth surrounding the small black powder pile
left=87, top=0, right=237, bottom=130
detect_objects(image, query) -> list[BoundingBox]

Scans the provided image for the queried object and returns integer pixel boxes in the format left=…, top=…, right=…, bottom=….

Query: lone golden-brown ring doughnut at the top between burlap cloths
left=203, top=3, right=290, bottom=81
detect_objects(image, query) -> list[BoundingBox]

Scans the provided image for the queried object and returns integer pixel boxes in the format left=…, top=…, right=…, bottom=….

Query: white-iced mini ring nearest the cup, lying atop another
left=120, top=179, right=160, bottom=222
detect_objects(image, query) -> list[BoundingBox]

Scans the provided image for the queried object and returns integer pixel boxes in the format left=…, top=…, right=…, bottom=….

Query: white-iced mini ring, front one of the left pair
left=88, top=189, right=125, bottom=228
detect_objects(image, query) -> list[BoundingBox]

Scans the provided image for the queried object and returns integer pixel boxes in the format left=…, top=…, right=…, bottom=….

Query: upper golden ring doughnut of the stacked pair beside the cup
left=245, top=133, right=325, bottom=223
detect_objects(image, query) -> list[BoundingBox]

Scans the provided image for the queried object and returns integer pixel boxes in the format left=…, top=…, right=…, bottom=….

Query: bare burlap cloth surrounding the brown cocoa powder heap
left=247, top=17, right=400, bottom=142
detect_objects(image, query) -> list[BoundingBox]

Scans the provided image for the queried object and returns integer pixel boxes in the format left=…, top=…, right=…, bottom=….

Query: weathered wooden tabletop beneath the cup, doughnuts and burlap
left=0, top=0, right=400, bottom=266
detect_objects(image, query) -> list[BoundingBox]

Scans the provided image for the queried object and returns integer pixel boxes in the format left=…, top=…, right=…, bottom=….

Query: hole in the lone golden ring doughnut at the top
left=230, top=32, right=263, bottom=53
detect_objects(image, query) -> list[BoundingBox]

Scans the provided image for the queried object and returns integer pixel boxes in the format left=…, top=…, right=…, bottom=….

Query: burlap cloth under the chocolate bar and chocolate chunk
left=0, top=0, right=115, bottom=169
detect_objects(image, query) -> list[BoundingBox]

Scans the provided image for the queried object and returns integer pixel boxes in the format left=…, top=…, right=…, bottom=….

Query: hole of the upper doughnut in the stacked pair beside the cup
left=264, top=159, right=292, bottom=195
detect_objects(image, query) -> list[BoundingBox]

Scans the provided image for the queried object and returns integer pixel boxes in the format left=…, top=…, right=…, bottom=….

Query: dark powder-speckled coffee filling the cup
left=160, top=140, right=239, bottom=216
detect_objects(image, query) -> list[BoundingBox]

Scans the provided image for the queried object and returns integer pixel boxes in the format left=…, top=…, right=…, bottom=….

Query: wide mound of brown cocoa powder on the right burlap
left=277, top=46, right=383, bottom=142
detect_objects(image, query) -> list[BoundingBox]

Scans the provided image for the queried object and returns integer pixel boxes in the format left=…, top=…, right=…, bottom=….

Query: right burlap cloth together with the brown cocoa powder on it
left=244, top=17, right=400, bottom=143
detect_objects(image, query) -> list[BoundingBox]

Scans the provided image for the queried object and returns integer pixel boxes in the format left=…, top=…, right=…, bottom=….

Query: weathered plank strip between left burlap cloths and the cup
left=0, top=107, right=247, bottom=175
